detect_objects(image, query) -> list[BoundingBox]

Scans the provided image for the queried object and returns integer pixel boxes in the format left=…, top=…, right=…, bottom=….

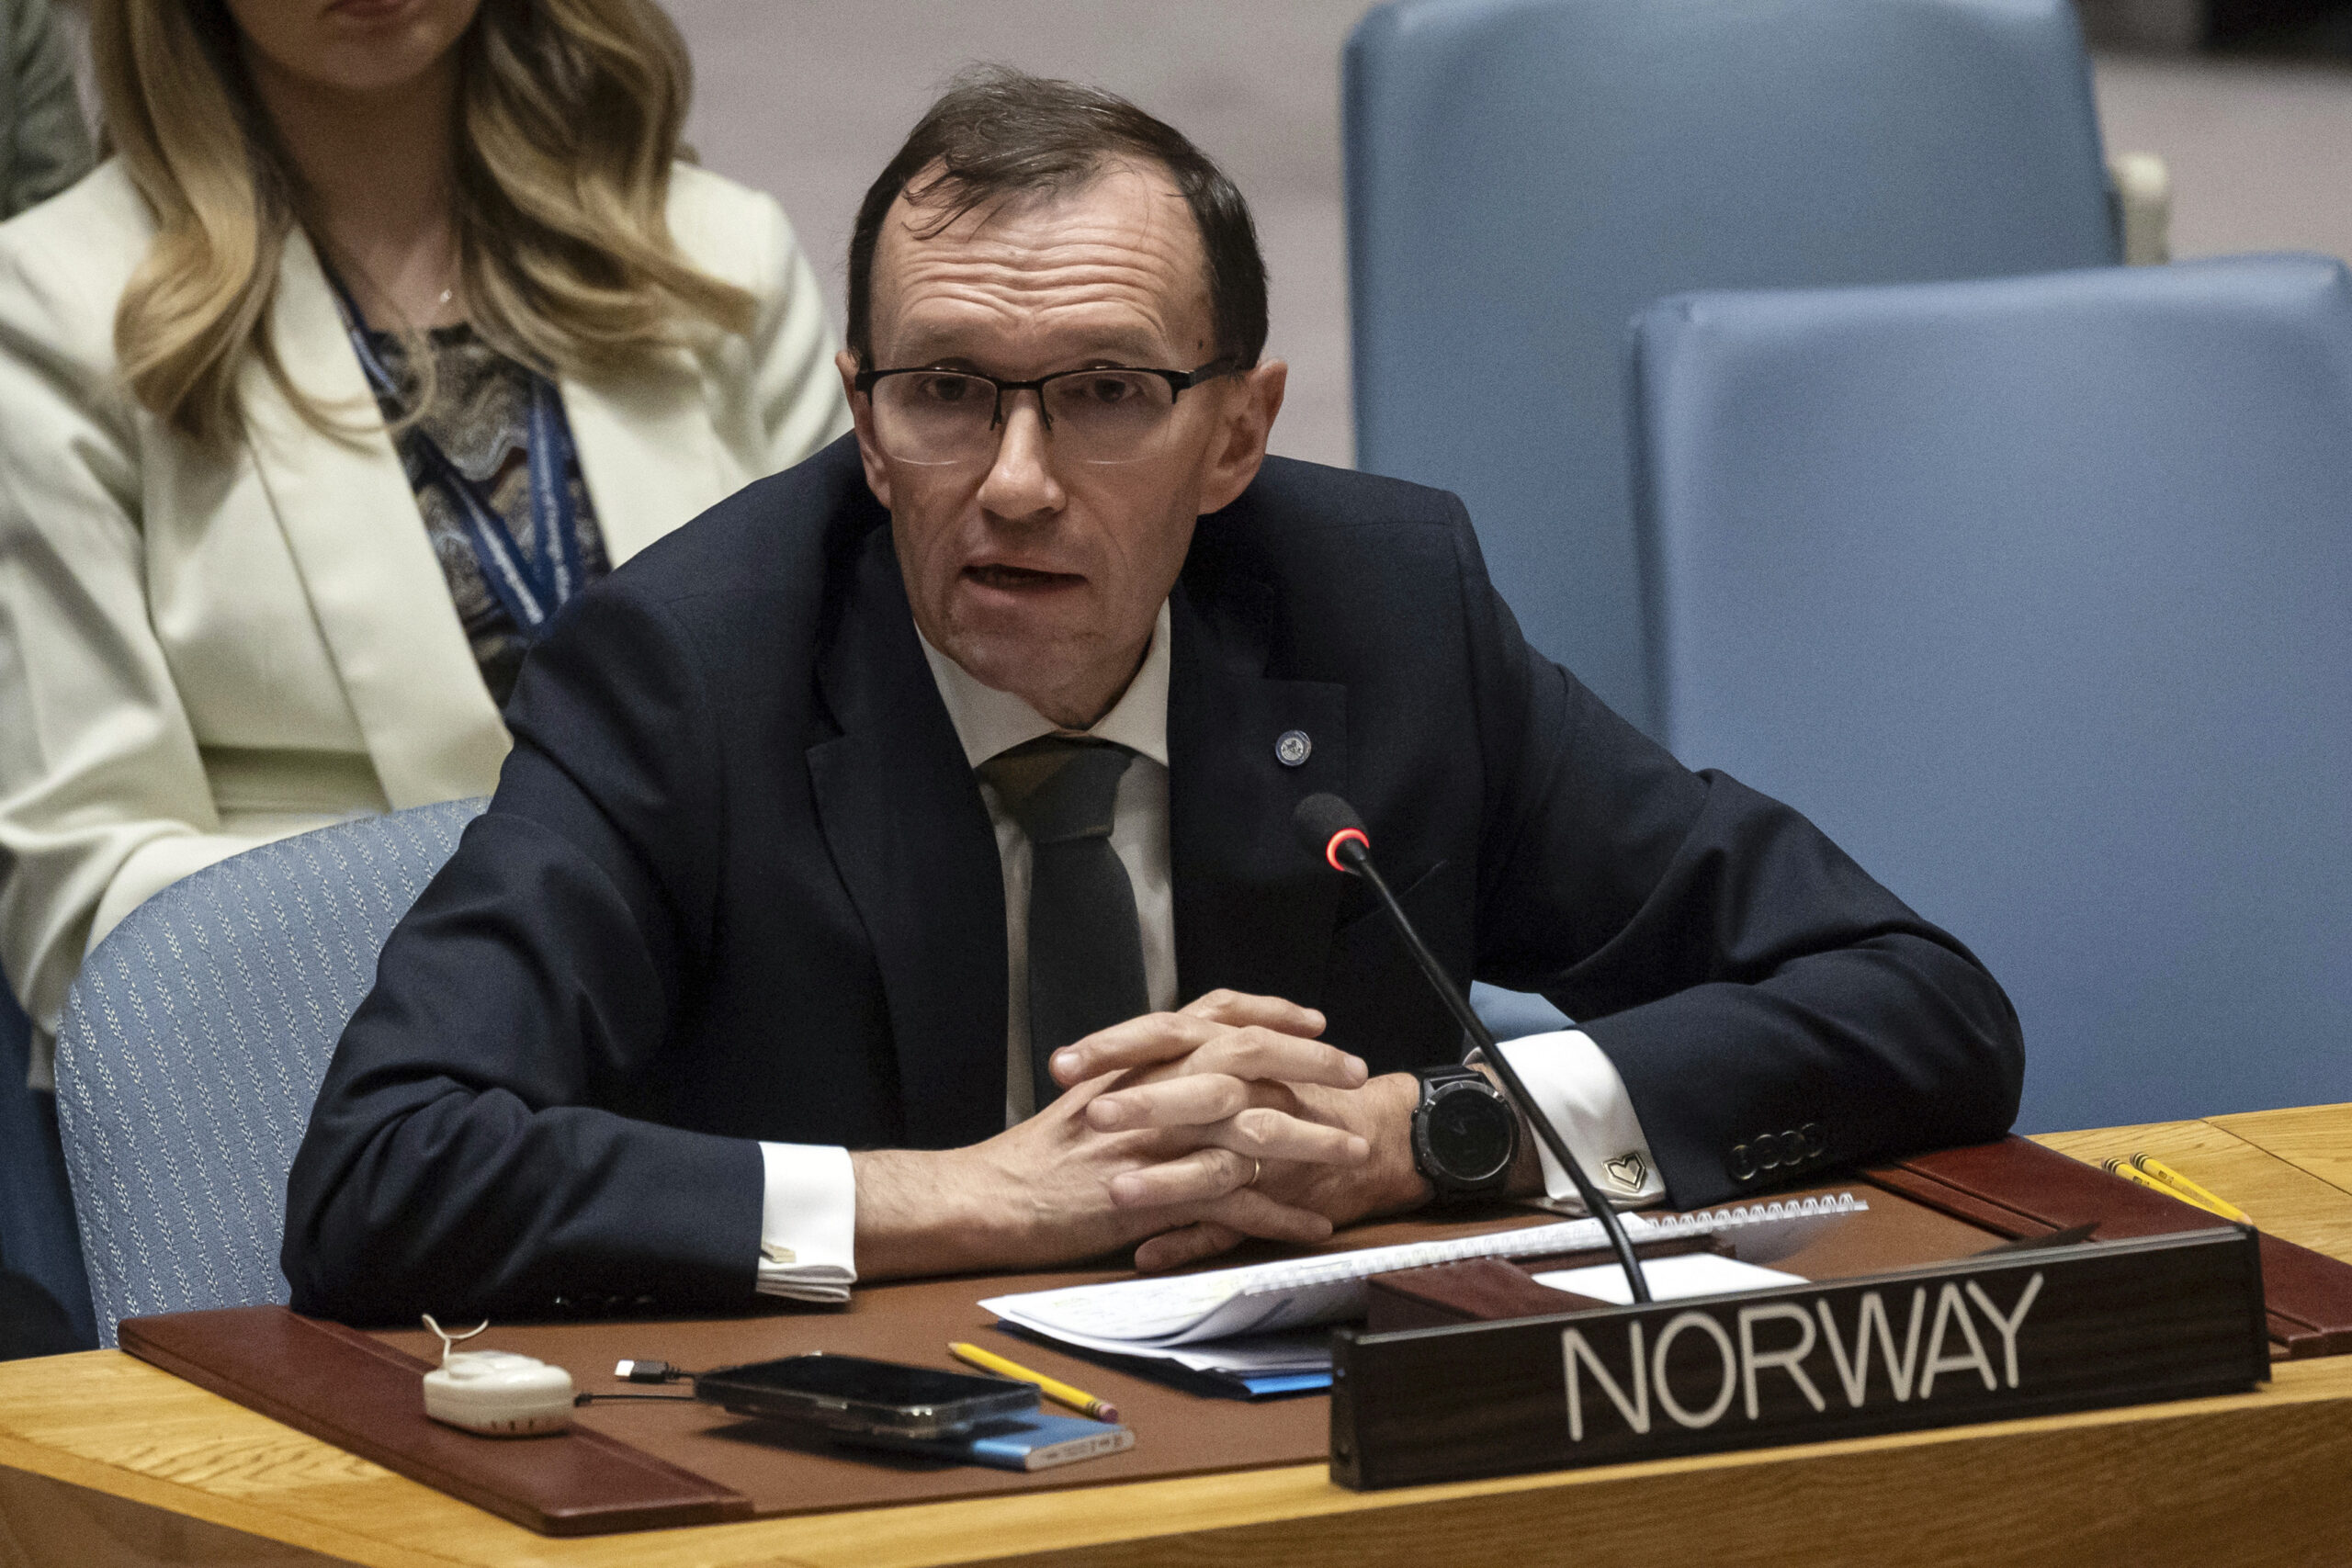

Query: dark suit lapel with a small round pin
left=1169, top=583, right=1348, bottom=1006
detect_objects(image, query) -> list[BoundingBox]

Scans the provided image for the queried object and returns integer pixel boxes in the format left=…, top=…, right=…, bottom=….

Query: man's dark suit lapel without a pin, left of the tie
left=809, top=526, right=1004, bottom=1149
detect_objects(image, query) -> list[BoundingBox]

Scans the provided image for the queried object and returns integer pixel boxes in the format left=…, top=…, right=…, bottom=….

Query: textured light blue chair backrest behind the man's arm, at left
left=56, top=799, right=484, bottom=1345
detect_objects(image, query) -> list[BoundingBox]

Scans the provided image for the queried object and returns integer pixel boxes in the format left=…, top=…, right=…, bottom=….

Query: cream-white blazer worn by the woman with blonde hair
left=0, top=160, right=849, bottom=1084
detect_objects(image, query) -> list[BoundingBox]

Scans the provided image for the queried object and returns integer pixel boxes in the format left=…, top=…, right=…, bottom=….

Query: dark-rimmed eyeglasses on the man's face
left=852, top=355, right=1242, bottom=466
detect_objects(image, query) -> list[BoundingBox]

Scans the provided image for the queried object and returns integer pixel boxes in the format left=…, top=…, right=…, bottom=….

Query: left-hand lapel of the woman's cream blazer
left=238, top=232, right=508, bottom=808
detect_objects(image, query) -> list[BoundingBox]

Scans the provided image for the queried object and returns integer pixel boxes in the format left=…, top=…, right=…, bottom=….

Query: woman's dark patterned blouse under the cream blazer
left=367, top=324, right=612, bottom=707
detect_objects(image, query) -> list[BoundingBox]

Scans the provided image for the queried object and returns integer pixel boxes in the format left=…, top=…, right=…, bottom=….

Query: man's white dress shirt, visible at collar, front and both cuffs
left=760, top=604, right=1665, bottom=1300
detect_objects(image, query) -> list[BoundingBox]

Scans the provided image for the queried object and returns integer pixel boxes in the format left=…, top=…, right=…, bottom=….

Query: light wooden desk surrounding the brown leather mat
left=0, top=1105, right=2352, bottom=1568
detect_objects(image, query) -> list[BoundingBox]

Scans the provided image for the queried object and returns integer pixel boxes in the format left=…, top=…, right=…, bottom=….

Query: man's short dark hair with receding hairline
left=849, top=66, right=1265, bottom=369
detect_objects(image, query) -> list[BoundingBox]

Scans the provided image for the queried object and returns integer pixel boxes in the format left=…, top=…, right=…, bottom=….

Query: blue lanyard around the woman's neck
left=329, top=277, right=585, bottom=642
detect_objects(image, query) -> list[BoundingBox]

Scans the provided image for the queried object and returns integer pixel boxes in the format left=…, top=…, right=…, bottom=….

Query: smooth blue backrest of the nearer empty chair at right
left=1633, top=256, right=2352, bottom=1131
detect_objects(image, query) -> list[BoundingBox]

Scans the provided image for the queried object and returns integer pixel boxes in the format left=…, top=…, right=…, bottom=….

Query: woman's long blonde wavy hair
left=89, top=0, right=755, bottom=445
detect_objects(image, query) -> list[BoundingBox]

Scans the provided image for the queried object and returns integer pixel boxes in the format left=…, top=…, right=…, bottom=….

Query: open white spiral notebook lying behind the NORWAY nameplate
left=981, top=1192, right=1870, bottom=1375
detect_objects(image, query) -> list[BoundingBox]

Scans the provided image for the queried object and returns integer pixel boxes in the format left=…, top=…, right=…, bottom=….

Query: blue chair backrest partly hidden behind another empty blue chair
left=1345, top=0, right=2121, bottom=728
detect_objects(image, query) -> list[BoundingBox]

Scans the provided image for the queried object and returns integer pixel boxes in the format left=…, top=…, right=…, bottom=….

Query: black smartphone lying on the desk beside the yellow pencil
left=694, top=1354, right=1037, bottom=1437
